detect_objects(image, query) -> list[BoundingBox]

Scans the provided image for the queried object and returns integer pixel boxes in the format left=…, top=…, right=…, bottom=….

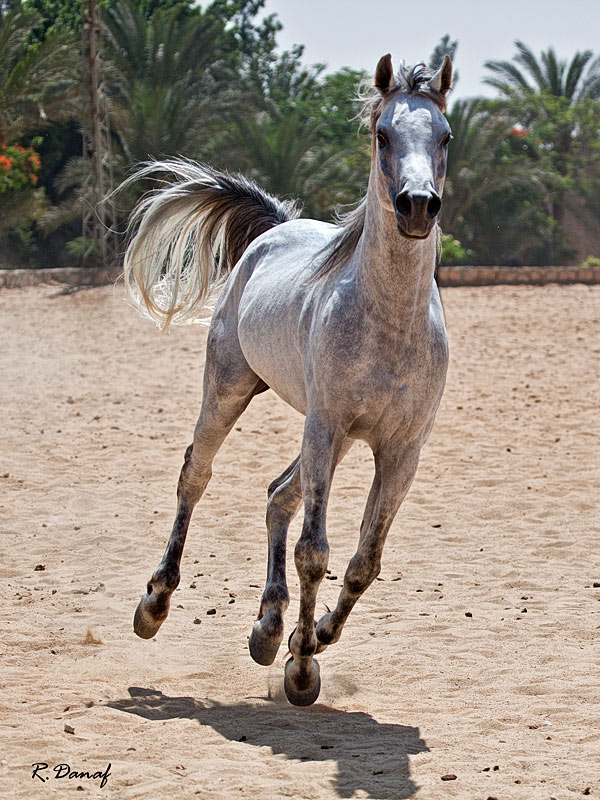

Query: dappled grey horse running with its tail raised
left=124, top=54, right=452, bottom=706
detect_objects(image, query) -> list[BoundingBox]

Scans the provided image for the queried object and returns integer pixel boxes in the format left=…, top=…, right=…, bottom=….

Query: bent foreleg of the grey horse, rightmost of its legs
left=316, top=446, right=419, bottom=653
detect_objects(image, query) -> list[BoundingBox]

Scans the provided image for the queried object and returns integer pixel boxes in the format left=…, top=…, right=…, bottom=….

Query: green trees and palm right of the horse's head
left=444, top=42, right=600, bottom=264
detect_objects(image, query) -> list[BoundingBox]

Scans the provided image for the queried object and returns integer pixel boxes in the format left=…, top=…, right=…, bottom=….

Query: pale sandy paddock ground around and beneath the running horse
left=0, top=286, right=600, bottom=800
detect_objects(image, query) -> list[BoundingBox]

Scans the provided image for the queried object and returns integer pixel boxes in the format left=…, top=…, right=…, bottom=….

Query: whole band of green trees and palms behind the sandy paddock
left=0, top=12, right=600, bottom=264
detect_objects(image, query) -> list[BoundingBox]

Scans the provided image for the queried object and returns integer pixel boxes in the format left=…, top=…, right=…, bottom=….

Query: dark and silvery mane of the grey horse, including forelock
left=312, top=63, right=447, bottom=281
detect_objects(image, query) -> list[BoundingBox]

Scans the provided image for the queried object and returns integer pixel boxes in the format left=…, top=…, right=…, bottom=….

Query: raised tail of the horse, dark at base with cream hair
left=123, top=159, right=300, bottom=330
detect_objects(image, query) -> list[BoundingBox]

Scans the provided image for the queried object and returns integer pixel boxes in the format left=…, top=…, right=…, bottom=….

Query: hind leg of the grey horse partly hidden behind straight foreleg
left=248, top=456, right=302, bottom=666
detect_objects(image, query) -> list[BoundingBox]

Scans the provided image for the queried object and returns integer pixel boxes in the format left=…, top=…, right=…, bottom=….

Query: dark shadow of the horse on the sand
left=107, top=686, right=429, bottom=800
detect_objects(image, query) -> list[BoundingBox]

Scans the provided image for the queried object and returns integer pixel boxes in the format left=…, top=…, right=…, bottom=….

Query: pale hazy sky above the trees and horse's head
left=265, top=0, right=600, bottom=97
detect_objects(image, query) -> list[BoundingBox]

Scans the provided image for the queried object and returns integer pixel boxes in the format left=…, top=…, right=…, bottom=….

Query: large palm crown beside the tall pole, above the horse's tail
left=104, top=0, right=232, bottom=164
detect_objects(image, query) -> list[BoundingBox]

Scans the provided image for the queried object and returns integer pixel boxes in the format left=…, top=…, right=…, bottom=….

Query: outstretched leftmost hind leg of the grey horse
left=133, top=322, right=268, bottom=639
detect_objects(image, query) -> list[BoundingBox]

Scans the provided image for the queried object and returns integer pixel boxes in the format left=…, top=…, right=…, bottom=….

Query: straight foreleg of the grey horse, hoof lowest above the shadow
left=284, top=413, right=345, bottom=706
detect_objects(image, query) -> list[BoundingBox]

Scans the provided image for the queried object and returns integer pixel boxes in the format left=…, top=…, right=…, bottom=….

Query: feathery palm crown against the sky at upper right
left=484, top=40, right=600, bottom=104
